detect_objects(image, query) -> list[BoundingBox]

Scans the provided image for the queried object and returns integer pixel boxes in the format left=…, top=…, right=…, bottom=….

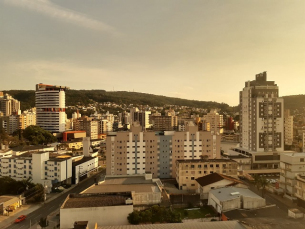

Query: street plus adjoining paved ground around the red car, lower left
left=0, top=171, right=104, bottom=229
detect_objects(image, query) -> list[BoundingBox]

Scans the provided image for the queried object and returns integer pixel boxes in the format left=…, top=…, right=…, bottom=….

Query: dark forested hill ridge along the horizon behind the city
left=4, top=90, right=305, bottom=111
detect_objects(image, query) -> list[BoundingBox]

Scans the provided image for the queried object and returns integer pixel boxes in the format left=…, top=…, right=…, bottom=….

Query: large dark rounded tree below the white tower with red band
left=23, top=126, right=57, bottom=145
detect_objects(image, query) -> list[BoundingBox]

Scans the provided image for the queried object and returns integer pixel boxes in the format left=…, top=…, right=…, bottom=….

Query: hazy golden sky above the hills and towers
left=0, top=0, right=305, bottom=105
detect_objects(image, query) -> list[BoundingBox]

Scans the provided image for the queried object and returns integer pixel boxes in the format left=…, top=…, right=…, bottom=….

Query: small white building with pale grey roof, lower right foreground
left=208, top=187, right=266, bottom=213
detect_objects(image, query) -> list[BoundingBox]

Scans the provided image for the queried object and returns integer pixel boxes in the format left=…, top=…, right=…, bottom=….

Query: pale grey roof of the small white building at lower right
left=210, top=187, right=262, bottom=201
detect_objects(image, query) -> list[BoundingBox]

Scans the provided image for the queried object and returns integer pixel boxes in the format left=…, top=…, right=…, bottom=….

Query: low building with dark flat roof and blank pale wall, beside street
left=60, top=192, right=133, bottom=229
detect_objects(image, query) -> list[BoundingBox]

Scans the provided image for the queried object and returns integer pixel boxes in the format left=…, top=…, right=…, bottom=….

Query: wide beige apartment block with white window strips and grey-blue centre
left=106, top=123, right=220, bottom=178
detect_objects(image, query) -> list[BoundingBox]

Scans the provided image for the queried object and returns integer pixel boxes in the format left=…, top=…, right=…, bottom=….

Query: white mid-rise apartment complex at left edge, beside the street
left=0, top=151, right=72, bottom=191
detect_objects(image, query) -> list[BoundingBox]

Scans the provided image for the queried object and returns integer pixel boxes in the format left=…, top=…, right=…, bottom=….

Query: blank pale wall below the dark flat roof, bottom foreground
left=60, top=205, right=133, bottom=229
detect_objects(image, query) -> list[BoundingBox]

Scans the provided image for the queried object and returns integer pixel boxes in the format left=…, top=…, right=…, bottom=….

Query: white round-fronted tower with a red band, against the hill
left=35, top=84, right=69, bottom=133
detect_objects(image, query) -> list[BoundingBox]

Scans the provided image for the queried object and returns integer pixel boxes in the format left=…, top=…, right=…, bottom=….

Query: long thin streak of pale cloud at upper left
left=4, top=0, right=118, bottom=34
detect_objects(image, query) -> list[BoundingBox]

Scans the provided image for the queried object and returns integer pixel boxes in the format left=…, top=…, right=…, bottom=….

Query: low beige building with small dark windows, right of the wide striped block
left=176, top=159, right=238, bottom=192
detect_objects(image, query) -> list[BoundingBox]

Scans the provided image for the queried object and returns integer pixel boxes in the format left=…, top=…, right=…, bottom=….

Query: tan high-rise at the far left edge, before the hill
left=0, top=92, right=20, bottom=116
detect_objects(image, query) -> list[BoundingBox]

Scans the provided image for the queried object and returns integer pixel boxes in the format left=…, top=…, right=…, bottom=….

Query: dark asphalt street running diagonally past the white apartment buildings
left=7, top=171, right=105, bottom=229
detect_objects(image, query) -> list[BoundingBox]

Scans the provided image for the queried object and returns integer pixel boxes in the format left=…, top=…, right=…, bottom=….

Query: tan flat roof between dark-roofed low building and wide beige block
left=84, top=176, right=160, bottom=193
